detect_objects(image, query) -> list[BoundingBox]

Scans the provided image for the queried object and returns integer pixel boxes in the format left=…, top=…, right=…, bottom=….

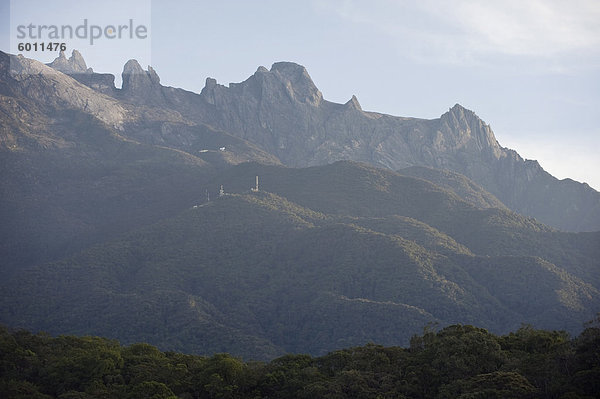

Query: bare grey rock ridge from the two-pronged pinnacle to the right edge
left=39, top=55, right=600, bottom=231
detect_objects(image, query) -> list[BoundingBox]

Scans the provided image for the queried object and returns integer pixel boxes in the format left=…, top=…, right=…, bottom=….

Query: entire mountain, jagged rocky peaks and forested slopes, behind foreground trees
left=0, top=51, right=600, bottom=359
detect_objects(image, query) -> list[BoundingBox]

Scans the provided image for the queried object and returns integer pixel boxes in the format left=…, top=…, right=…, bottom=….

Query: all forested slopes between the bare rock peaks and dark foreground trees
left=0, top=107, right=600, bottom=360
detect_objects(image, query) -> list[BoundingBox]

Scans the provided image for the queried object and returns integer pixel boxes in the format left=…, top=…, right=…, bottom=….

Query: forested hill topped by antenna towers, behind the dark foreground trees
left=0, top=189, right=600, bottom=360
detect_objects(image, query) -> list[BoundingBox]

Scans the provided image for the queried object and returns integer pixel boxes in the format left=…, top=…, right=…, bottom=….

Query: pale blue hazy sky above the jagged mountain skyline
left=0, top=0, right=600, bottom=189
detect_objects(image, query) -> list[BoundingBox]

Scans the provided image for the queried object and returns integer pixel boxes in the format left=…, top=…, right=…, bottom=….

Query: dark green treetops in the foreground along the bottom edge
left=0, top=324, right=600, bottom=399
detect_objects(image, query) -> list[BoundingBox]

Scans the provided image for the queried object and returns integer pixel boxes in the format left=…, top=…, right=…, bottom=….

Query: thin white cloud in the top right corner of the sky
left=317, top=0, right=600, bottom=70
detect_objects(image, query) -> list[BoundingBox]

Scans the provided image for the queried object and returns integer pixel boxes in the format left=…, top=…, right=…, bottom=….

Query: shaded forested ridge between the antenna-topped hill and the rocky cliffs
left=214, top=161, right=600, bottom=289
